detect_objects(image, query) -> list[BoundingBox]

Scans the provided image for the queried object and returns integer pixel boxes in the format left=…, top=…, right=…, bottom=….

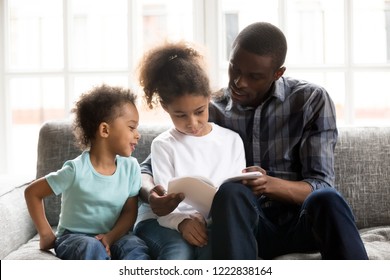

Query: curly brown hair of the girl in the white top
left=138, top=41, right=211, bottom=109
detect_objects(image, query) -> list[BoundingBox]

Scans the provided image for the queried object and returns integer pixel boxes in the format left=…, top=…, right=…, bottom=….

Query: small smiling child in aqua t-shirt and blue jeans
left=25, top=85, right=149, bottom=260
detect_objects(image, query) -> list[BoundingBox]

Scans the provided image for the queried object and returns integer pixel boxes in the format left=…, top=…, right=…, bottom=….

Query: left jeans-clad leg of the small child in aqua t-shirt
left=54, top=233, right=110, bottom=260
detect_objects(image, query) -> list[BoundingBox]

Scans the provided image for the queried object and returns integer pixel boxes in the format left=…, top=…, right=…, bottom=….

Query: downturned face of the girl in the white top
left=162, top=94, right=211, bottom=136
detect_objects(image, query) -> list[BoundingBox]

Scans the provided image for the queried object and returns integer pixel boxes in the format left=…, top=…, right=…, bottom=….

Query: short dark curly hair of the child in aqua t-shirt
left=72, top=84, right=136, bottom=149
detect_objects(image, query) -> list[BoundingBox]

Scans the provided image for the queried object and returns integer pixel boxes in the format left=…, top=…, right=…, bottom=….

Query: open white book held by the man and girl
left=168, top=171, right=262, bottom=218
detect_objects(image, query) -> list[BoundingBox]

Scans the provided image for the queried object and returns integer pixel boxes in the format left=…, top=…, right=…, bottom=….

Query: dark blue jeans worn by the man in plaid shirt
left=211, top=183, right=368, bottom=259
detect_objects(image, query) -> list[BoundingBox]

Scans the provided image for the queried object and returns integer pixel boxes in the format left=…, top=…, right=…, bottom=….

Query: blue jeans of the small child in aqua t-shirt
left=54, top=231, right=150, bottom=260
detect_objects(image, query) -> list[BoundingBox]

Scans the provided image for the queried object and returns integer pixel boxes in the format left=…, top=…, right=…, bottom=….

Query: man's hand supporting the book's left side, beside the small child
left=148, top=186, right=184, bottom=216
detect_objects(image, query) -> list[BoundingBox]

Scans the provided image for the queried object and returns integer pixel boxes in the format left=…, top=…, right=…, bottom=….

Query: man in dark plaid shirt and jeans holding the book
left=140, top=22, right=368, bottom=259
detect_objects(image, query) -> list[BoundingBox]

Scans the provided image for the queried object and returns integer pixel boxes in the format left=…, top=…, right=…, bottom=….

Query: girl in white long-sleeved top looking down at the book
left=135, top=42, right=245, bottom=259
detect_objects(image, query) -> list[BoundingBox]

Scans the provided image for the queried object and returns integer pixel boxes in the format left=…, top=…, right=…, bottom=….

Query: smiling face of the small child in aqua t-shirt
left=109, top=103, right=141, bottom=157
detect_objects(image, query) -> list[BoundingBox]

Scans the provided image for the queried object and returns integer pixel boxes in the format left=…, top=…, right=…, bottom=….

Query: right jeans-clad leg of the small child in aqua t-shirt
left=110, top=233, right=150, bottom=260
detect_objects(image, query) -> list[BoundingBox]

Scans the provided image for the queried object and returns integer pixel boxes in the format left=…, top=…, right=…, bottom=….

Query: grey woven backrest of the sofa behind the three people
left=37, top=121, right=390, bottom=228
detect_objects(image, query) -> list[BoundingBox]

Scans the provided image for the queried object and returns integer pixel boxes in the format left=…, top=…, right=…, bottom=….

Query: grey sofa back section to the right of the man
left=335, top=127, right=390, bottom=228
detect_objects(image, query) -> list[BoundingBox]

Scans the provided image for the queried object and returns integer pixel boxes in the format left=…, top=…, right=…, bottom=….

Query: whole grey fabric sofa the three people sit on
left=0, top=121, right=390, bottom=260
